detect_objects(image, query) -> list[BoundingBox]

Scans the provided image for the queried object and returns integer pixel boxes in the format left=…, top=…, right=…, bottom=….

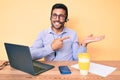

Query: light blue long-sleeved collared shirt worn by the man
left=30, top=27, right=86, bottom=61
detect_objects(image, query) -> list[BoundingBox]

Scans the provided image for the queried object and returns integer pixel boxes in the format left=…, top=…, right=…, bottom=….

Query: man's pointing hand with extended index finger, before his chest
left=51, top=36, right=69, bottom=51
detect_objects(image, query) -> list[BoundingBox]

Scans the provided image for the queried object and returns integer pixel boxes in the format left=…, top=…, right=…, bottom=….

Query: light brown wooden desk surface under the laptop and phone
left=0, top=61, right=120, bottom=80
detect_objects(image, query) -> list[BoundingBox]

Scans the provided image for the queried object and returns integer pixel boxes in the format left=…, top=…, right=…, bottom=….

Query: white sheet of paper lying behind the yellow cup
left=71, top=62, right=116, bottom=77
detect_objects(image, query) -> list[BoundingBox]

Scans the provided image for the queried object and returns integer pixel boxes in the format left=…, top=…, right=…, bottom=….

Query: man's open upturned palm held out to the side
left=82, top=34, right=105, bottom=46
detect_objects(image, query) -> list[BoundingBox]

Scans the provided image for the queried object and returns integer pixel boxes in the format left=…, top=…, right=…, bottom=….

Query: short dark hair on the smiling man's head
left=51, top=3, right=68, bottom=22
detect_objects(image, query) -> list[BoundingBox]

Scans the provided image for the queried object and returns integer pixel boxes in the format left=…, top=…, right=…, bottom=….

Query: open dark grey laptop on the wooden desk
left=4, top=43, right=54, bottom=75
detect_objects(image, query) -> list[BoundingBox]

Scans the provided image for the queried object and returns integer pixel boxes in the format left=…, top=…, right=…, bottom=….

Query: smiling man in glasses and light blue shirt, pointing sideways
left=30, top=4, right=104, bottom=61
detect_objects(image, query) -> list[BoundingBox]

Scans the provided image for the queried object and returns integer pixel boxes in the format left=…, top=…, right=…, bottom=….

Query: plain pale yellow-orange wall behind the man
left=0, top=0, right=120, bottom=60
